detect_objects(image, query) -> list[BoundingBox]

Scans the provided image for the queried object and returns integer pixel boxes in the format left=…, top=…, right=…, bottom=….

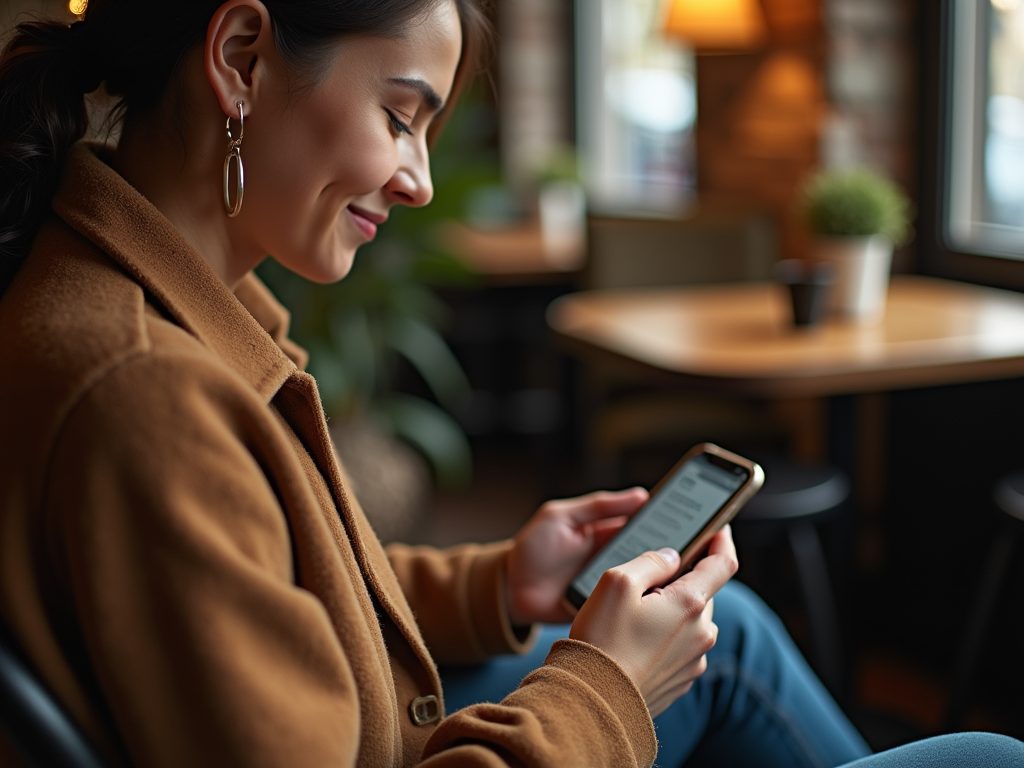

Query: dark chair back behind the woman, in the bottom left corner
left=0, top=625, right=102, bottom=768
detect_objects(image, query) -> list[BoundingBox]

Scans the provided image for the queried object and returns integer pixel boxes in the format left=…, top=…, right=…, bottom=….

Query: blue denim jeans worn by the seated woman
left=441, top=582, right=1024, bottom=768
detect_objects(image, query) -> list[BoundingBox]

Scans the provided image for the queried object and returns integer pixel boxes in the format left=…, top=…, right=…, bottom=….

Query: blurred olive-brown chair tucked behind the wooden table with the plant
left=579, top=204, right=779, bottom=483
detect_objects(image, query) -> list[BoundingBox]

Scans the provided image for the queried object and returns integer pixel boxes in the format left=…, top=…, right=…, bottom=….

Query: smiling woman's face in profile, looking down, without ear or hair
left=231, top=1, right=462, bottom=283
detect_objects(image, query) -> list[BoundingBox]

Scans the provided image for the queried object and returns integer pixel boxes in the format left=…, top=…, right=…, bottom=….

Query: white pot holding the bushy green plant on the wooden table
left=814, top=234, right=893, bottom=324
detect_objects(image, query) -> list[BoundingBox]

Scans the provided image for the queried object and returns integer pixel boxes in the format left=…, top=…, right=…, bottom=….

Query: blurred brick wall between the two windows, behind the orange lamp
left=697, top=0, right=914, bottom=262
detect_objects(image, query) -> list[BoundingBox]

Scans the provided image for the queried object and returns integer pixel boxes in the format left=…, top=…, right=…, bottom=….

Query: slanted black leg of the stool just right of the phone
left=788, top=522, right=846, bottom=699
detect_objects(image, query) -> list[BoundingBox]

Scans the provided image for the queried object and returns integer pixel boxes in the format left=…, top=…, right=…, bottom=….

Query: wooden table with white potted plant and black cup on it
left=548, top=276, right=1024, bottom=506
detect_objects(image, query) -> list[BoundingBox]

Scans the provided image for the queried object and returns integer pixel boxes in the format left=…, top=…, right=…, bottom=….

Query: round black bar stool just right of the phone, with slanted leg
left=733, top=456, right=850, bottom=697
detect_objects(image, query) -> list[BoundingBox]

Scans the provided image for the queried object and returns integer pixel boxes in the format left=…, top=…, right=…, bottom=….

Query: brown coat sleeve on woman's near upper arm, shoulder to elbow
left=46, top=354, right=359, bottom=768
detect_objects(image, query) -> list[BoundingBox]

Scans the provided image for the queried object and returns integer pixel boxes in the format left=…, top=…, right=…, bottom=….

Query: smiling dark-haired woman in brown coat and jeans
left=0, top=0, right=1010, bottom=766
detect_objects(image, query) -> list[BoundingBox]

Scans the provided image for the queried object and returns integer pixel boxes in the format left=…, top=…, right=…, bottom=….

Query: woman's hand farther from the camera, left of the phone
left=506, top=488, right=648, bottom=626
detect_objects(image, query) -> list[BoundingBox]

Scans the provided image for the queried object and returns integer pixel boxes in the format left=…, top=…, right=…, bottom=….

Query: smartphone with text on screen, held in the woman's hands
left=565, top=442, right=765, bottom=611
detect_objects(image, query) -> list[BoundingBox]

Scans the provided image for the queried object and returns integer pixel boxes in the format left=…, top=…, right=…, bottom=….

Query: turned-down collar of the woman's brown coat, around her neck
left=53, top=141, right=305, bottom=402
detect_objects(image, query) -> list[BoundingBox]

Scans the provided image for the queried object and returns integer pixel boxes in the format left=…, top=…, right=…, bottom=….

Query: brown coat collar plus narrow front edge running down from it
left=53, top=142, right=440, bottom=704
